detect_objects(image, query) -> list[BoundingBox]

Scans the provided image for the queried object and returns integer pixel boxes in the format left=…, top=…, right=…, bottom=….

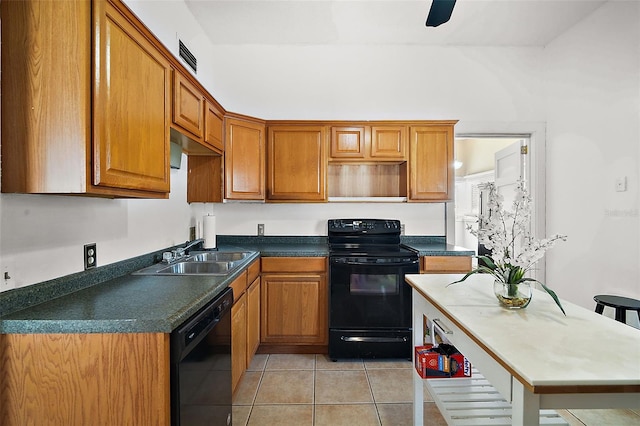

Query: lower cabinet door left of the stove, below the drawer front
left=261, top=274, right=329, bottom=345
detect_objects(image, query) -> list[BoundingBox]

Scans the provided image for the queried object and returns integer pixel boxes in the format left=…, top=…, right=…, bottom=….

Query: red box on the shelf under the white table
left=415, top=345, right=471, bottom=379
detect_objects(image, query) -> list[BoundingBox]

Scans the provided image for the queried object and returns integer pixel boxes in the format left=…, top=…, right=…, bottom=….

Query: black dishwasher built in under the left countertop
left=171, top=288, right=233, bottom=426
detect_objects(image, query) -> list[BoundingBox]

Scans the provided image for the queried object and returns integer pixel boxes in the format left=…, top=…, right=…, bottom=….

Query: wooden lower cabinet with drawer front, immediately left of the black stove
left=261, top=257, right=328, bottom=345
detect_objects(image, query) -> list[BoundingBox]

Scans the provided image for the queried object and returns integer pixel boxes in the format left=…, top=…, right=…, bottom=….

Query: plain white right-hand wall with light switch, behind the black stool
left=544, top=2, right=640, bottom=323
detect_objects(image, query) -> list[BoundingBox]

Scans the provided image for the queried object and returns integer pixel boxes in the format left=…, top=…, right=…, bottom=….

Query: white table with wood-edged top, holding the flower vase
left=406, top=274, right=640, bottom=426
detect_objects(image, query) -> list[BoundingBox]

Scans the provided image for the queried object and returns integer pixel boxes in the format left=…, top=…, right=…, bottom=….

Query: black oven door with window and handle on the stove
left=329, top=256, right=419, bottom=330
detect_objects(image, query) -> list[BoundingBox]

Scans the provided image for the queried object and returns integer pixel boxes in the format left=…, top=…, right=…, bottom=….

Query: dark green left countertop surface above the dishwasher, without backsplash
left=0, top=252, right=259, bottom=333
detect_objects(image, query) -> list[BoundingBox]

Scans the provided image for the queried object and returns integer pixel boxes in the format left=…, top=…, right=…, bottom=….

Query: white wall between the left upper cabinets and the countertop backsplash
left=0, top=156, right=192, bottom=291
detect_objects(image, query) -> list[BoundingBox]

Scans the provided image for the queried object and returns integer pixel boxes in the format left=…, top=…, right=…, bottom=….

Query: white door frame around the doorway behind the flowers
left=445, top=123, right=546, bottom=282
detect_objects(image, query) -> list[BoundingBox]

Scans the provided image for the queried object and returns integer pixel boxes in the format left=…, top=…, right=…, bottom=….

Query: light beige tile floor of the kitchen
left=233, top=354, right=640, bottom=426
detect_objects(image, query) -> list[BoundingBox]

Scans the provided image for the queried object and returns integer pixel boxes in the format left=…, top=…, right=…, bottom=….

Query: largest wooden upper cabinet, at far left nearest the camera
left=0, top=0, right=170, bottom=198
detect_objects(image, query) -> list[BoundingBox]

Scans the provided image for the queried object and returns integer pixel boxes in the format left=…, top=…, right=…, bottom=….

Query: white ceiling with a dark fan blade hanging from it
left=185, top=0, right=605, bottom=46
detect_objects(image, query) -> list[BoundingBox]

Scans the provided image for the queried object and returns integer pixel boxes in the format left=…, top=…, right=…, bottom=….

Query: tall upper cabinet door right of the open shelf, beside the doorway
left=409, top=125, right=454, bottom=201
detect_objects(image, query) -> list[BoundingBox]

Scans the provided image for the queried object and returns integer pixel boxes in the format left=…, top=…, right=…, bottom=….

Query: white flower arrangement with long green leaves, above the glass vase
left=451, top=180, right=567, bottom=315
